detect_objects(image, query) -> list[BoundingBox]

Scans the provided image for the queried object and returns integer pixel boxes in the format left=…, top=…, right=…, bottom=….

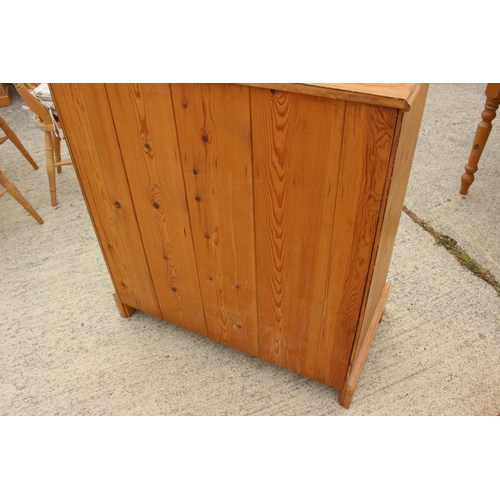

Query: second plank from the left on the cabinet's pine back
left=106, top=84, right=207, bottom=335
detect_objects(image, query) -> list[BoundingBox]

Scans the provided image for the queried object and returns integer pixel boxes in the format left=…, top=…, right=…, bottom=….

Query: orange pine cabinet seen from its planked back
left=50, top=84, right=427, bottom=407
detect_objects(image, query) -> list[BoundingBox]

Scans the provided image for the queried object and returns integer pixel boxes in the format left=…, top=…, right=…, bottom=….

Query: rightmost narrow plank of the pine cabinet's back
left=315, top=103, right=397, bottom=388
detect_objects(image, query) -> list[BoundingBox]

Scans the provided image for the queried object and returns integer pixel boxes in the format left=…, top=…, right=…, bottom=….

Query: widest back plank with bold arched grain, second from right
left=251, top=88, right=345, bottom=377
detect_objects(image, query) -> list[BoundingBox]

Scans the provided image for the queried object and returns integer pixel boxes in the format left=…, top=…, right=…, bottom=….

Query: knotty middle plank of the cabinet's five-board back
left=171, top=84, right=258, bottom=355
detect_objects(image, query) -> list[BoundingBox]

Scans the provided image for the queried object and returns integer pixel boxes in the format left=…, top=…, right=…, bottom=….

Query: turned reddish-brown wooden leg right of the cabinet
left=460, top=83, right=500, bottom=194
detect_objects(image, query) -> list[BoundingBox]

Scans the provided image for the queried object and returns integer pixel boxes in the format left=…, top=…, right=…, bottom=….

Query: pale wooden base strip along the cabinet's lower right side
left=338, top=283, right=391, bottom=408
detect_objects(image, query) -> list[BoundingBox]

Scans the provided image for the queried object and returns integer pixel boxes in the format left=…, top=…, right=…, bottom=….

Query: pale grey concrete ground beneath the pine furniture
left=0, top=84, right=500, bottom=415
